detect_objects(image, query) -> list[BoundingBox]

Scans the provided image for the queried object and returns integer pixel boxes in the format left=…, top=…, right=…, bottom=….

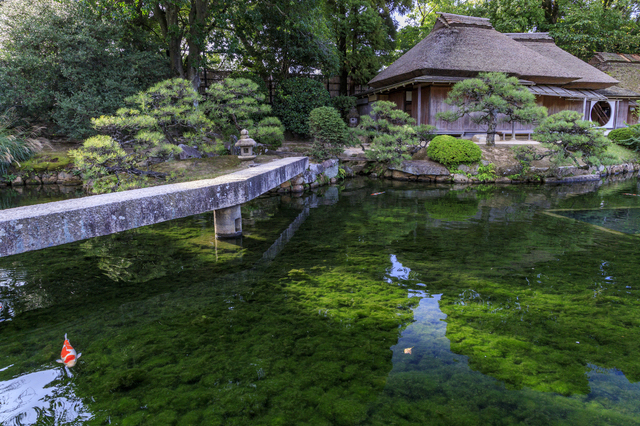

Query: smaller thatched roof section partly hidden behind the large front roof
left=505, top=33, right=618, bottom=89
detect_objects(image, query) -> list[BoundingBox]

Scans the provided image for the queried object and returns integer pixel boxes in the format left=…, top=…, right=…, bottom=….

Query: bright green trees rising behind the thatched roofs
left=396, top=0, right=640, bottom=60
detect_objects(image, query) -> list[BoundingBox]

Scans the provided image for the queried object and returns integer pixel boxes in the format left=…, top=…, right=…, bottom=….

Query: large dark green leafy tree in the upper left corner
left=0, top=0, right=168, bottom=138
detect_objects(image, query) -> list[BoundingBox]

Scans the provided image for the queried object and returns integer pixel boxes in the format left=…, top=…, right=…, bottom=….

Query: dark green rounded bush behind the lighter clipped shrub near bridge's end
left=273, top=77, right=330, bottom=137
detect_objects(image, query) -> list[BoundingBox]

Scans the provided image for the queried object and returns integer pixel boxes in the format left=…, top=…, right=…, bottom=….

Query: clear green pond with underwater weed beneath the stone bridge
left=0, top=178, right=640, bottom=425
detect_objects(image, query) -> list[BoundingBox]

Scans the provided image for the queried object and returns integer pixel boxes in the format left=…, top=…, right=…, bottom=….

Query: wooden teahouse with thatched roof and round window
left=358, top=13, right=640, bottom=136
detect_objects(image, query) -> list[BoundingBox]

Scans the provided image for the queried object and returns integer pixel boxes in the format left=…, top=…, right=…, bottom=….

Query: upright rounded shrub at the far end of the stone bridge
left=309, top=107, right=351, bottom=160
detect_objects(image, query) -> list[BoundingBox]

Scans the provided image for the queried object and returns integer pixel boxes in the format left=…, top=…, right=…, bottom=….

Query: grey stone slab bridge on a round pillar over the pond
left=0, top=157, right=309, bottom=256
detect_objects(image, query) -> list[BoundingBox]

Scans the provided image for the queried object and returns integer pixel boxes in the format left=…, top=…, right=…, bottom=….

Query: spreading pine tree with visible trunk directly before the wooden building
left=437, top=73, right=547, bottom=145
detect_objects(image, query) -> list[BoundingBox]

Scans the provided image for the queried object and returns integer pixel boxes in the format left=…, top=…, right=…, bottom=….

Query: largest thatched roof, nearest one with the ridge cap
left=369, top=13, right=581, bottom=88
